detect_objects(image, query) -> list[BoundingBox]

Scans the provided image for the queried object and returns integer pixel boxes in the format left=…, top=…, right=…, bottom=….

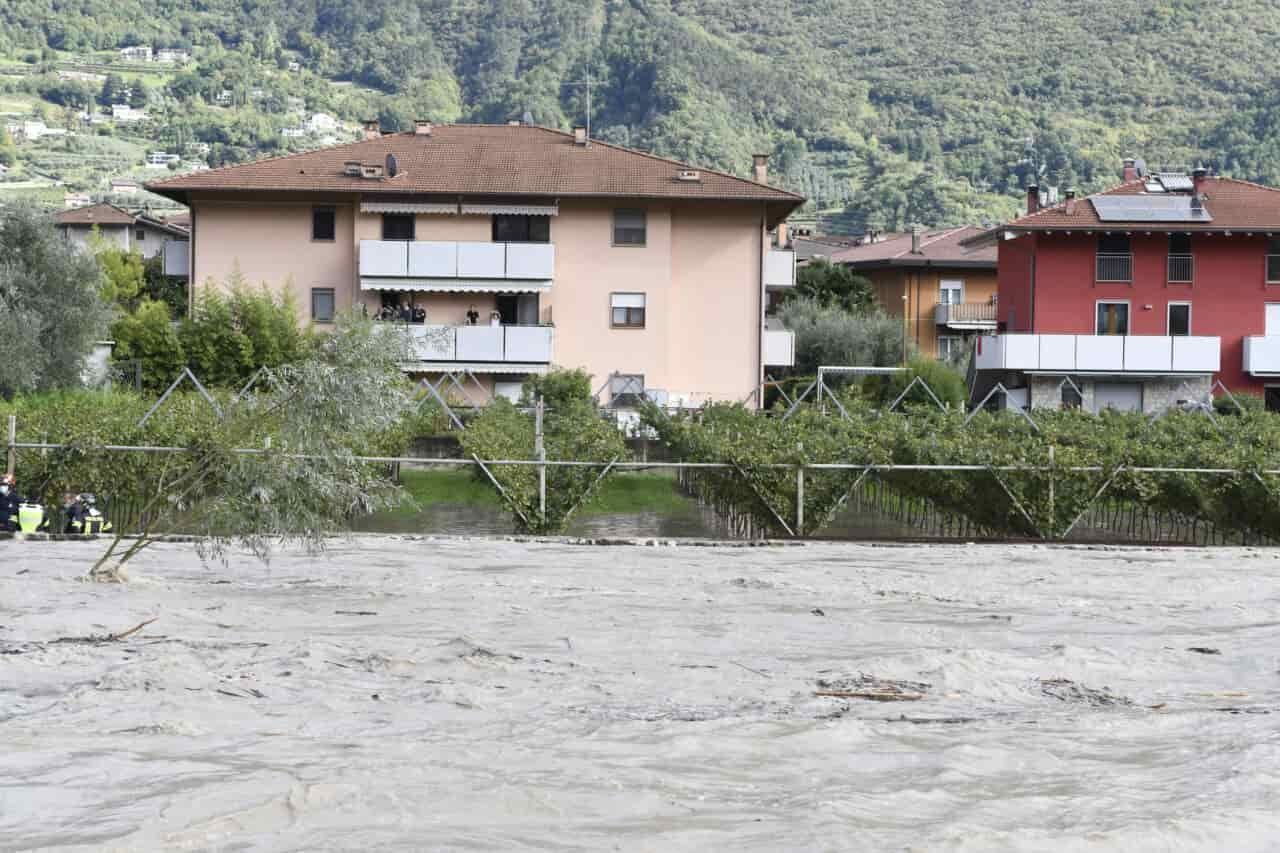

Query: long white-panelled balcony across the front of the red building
left=977, top=334, right=1221, bottom=375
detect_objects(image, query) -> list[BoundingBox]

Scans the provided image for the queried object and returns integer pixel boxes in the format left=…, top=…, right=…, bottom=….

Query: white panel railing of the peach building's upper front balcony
left=360, top=240, right=556, bottom=281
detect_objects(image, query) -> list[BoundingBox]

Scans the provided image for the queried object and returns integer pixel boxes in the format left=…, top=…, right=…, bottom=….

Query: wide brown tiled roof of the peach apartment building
left=147, top=124, right=804, bottom=211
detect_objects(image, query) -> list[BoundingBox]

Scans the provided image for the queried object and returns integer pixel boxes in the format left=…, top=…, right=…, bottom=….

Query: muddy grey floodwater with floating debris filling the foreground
left=0, top=537, right=1280, bottom=853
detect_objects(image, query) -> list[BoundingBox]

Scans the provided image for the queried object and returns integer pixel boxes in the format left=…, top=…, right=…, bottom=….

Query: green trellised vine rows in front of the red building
left=645, top=397, right=1280, bottom=539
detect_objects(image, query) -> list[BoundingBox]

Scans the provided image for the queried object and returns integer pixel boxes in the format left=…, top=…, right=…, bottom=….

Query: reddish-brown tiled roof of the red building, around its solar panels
left=1001, top=177, right=1280, bottom=231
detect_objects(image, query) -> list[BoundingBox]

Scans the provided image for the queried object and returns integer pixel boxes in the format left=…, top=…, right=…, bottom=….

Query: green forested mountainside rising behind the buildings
left=0, top=0, right=1280, bottom=229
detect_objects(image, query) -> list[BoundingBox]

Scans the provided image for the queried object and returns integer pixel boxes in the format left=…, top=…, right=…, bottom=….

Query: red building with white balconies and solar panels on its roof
left=974, top=160, right=1280, bottom=411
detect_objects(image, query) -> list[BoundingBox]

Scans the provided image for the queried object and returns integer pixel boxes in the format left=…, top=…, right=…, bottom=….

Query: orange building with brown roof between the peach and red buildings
left=829, top=225, right=996, bottom=360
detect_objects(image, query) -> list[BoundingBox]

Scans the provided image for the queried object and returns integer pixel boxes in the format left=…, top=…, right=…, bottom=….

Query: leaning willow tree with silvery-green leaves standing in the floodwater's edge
left=90, top=316, right=410, bottom=580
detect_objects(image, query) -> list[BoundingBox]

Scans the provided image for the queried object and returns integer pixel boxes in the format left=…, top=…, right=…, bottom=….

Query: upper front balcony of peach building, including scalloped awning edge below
left=360, top=240, right=556, bottom=291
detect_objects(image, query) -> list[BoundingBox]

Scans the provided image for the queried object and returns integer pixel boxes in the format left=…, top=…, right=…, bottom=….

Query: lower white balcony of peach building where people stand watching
left=388, top=324, right=556, bottom=373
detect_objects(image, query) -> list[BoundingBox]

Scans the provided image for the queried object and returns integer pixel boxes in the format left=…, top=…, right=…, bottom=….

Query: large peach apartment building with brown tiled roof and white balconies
left=148, top=122, right=804, bottom=405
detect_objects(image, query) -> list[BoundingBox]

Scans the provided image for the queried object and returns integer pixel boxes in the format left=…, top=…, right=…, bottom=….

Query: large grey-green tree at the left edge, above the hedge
left=0, top=205, right=106, bottom=397
